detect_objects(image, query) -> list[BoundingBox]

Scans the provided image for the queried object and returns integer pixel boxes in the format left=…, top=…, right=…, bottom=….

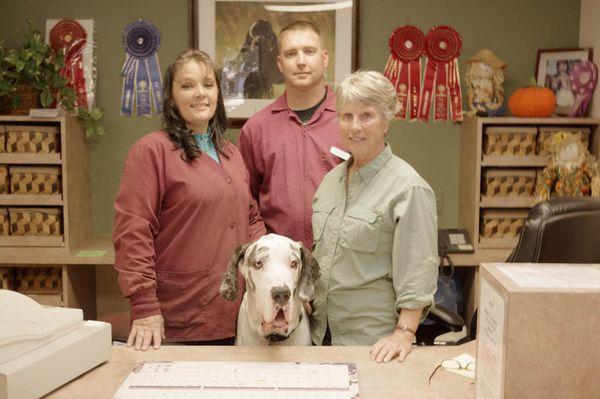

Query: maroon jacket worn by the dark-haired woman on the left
left=113, top=131, right=265, bottom=341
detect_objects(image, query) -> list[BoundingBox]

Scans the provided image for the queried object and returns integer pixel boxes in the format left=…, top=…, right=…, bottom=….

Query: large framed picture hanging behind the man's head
left=190, top=0, right=358, bottom=126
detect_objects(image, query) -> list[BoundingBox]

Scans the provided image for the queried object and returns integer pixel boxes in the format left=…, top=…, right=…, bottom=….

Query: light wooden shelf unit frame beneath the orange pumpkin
left=459, top=117, right=600, bottom=252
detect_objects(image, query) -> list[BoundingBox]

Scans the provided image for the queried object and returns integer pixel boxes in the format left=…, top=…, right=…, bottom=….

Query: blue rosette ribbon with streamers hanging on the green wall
left=121, top=19, right=163, bottom=116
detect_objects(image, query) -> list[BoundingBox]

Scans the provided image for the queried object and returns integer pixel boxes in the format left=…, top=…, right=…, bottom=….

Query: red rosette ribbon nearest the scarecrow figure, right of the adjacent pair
left=419, top=25, right=462, bottom=122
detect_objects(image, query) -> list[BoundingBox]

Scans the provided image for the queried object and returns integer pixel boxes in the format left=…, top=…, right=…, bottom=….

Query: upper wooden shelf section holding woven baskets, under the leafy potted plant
left=0, top=116, right=91, bottom=250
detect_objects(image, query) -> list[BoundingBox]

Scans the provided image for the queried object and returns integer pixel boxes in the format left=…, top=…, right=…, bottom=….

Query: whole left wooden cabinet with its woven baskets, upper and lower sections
left=0, top=116, right=96, bottom=318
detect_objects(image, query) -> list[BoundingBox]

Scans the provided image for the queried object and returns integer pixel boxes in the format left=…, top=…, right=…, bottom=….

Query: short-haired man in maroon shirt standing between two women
left=238, top=21, right=341, bottom=248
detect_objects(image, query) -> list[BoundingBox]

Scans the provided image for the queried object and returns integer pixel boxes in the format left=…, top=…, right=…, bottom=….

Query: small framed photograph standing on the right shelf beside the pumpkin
left=536, top=47, right=593, bottom=115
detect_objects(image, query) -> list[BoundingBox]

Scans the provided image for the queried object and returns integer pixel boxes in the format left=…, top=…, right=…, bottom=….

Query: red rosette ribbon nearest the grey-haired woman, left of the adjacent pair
left=384, top=25, right=425, bottom=120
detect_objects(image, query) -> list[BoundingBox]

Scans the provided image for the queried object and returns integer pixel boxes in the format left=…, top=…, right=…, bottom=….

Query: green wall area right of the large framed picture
left=360, top=0, right=580, bottom=227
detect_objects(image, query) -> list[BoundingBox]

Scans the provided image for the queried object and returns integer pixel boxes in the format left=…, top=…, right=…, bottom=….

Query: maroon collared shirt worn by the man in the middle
left=238, top=89, right=342, bottom=248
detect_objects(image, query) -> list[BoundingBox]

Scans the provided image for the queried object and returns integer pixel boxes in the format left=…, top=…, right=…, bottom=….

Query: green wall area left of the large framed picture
left=0, top=0, right=188, bottom=234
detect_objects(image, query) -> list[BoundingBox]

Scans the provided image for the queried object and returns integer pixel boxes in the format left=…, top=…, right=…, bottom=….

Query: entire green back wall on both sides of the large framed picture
left=0, top=0, right=580, bottom=234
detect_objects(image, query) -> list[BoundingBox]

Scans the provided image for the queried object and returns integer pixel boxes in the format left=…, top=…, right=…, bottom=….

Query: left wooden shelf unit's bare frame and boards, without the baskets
left=0, top=115, right=95, bottom=319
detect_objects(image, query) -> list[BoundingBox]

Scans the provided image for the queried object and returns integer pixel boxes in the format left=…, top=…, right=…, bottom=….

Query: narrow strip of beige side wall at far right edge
left=579, top=0, right=600, bottom=118
